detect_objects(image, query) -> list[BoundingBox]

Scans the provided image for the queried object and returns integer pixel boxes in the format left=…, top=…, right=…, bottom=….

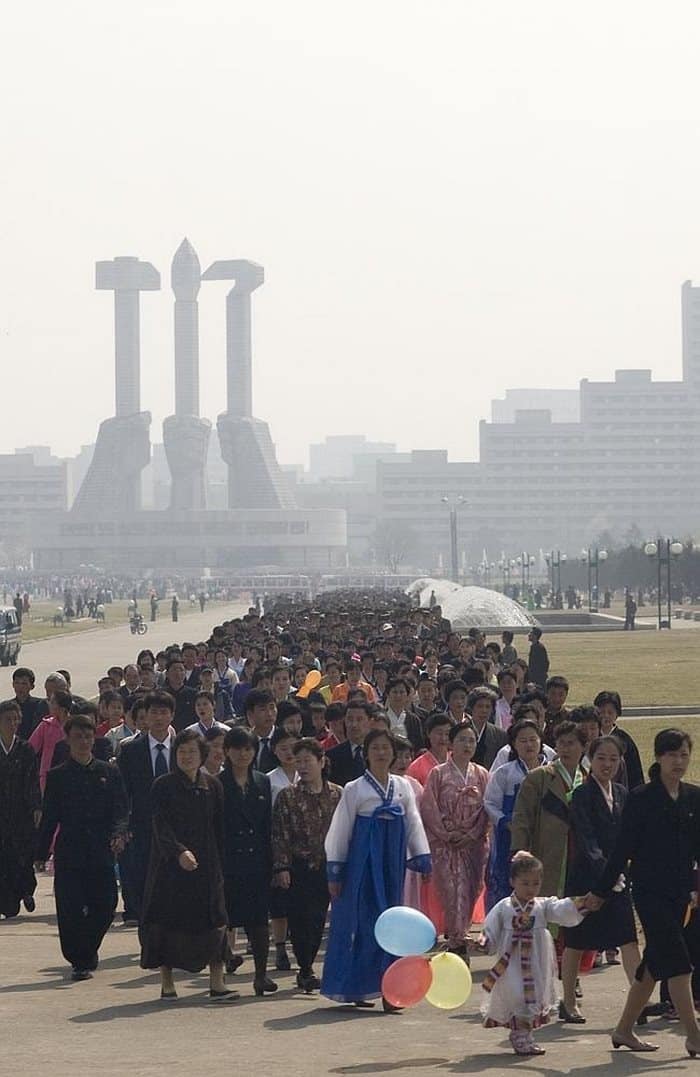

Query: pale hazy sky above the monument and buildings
left=0, top=0, right=700, bottom=463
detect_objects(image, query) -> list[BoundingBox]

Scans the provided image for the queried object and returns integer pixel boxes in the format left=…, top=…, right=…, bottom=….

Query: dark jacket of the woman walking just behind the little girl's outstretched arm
left=566, top=778, right=627, bottom=895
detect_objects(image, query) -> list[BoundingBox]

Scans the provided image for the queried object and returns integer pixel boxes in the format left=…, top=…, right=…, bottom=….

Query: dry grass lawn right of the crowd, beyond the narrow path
left=536, top=629, right=700, bottom=713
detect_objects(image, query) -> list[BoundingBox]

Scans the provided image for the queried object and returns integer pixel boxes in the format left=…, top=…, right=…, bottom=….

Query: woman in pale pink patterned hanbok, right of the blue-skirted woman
left=420, top=722, right=489, bottom=957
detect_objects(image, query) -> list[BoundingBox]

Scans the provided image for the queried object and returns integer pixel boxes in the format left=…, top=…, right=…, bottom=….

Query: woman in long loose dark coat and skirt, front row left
left=139, top=729, right=231, bottom=1002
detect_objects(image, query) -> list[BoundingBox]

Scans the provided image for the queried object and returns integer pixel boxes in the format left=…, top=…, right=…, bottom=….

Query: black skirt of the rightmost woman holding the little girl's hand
left=632, top=887, right=692, bottom=980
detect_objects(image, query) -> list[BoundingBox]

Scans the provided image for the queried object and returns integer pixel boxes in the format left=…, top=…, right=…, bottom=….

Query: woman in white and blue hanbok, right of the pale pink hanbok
left=484, top=718, right=546, bottom=911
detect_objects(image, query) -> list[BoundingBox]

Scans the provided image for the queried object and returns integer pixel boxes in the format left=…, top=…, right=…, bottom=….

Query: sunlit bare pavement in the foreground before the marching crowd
left=0, top=876, right=700, bottom=1077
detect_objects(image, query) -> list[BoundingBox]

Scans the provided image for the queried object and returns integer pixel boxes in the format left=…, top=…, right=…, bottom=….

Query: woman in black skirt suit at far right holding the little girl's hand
left=587, top=729, right=700, bottom=1058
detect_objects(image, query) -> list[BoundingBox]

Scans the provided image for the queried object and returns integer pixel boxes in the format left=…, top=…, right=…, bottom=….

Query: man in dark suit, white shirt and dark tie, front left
left=117, top=691, right=174, bottom=924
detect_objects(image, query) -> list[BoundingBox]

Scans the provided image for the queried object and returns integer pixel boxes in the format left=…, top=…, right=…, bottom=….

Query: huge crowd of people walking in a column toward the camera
left=0, top=593, right=700, bottom=1055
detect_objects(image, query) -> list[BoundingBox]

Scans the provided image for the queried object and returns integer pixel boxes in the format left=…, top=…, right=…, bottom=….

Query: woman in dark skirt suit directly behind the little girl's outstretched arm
left=559, top=737, right=640, bottom=1024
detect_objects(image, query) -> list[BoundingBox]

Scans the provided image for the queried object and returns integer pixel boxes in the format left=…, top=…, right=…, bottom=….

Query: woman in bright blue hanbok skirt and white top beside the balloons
left=321, top=729, right=431, bottom=1006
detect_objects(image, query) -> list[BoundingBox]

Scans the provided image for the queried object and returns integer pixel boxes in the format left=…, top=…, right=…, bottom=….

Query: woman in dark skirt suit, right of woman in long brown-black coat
left=220, top=726, right=277, bottom=995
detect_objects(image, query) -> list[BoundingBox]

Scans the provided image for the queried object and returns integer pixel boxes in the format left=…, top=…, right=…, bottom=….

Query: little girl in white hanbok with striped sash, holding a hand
left=479, top=852, right=583, bottom=1054
